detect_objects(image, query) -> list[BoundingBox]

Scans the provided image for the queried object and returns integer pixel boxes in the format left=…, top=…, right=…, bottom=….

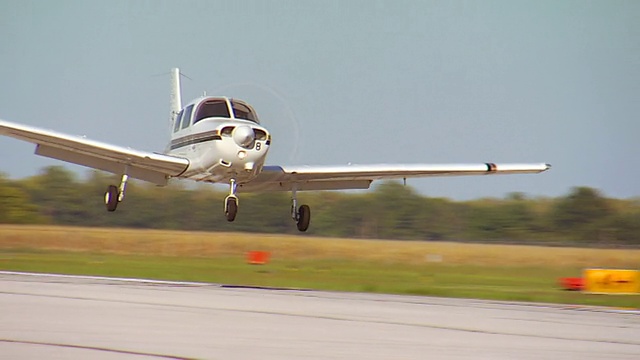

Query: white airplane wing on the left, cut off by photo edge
left=0, top=120, right=189, bottom=185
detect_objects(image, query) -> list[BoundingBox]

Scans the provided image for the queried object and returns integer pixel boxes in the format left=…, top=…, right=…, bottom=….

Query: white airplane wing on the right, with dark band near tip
left=239, top=163, right=551, bottom=191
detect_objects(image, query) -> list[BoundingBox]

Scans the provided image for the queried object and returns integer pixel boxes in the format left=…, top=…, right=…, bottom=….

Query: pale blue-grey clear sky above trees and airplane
left=0, top=0, right=640, bottom=199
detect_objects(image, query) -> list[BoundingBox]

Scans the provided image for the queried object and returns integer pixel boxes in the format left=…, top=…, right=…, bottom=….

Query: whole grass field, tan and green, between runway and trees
left=0, top=226, right=640, bottom=308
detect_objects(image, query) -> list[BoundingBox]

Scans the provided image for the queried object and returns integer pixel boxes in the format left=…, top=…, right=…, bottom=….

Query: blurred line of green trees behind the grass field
left=0, top=166, right=640, bottom=246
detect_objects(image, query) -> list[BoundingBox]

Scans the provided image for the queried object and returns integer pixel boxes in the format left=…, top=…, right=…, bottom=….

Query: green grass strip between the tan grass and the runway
left=0, top=248, right=640, bottom=308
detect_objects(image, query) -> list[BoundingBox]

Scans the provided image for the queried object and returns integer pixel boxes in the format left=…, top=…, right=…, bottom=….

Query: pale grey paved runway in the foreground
left=0, top=272, right=640, bottom=360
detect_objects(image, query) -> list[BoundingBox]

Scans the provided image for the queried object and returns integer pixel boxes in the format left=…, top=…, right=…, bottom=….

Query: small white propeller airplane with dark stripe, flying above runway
left=0, top=68, right=551, bottom=232
